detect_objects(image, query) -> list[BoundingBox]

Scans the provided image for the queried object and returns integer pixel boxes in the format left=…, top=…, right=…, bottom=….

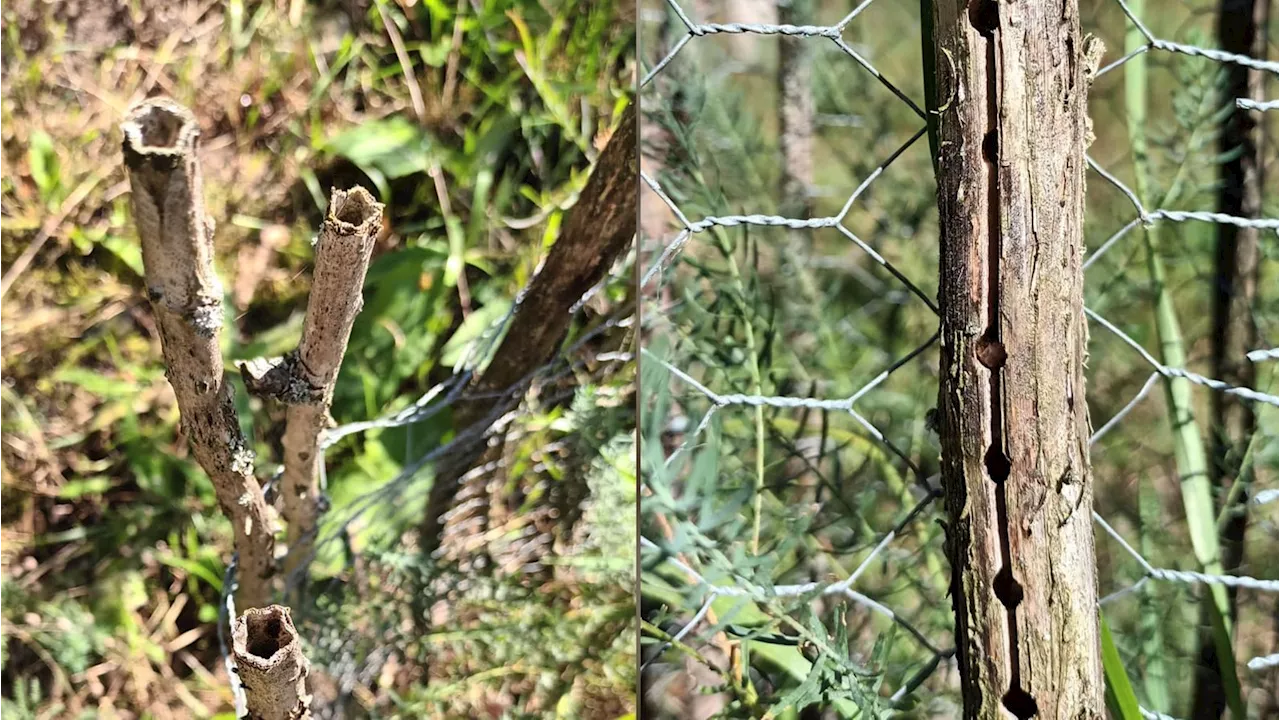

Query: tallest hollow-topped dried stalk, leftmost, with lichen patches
left=120, top=99, right=275, bottom=607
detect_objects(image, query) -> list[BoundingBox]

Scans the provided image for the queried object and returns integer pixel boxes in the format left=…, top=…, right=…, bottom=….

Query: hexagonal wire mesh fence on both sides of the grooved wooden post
left=640, top=0, right=1280, bottom=717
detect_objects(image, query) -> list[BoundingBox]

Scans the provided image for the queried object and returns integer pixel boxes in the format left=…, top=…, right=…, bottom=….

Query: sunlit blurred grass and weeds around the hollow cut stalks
left=0, top=0, right=634, bottom=717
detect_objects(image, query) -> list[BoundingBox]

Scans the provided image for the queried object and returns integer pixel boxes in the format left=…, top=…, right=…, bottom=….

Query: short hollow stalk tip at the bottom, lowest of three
left=232, top=605, right=311, bottom=720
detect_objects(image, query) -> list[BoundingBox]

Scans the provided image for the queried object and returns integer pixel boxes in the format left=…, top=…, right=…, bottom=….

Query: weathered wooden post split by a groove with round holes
left=932, top=0, right=1105, bottom=720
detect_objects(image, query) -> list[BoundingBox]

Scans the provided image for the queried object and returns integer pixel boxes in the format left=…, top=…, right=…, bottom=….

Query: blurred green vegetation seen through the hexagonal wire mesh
left=640, top=0, right=1280, bottom=717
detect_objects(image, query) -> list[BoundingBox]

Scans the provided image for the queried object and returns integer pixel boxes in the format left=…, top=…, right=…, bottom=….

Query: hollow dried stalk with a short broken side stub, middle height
left=243, top=187, right=383, bottom=580
